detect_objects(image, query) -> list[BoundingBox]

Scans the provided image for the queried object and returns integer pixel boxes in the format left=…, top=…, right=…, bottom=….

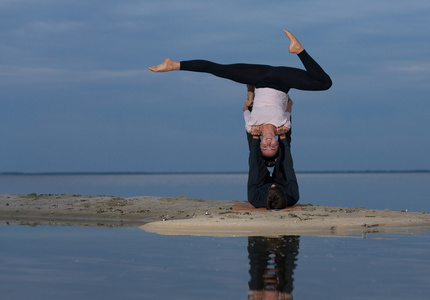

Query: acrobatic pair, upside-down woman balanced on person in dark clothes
left=149, top=30, right=332, bottom=209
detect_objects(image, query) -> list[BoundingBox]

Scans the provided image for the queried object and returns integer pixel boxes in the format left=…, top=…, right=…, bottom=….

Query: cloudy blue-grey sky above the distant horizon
left=0, top=0, right=430, bottom=173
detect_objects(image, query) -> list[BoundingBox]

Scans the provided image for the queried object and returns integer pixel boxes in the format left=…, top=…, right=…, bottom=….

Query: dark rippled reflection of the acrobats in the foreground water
left=248, top=236, right=300, bottom=300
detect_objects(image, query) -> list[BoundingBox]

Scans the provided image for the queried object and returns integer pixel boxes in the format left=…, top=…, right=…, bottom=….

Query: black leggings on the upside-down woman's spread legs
left=180, top=50, right=332, bottom=93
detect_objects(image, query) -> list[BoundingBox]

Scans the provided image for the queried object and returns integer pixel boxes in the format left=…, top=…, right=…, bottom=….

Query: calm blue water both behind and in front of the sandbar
left=0, top=173, right=430, bottom=299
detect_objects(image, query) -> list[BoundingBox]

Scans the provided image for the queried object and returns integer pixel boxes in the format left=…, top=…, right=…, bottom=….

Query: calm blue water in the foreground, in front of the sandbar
left=0, top=226, right=430, bottom=299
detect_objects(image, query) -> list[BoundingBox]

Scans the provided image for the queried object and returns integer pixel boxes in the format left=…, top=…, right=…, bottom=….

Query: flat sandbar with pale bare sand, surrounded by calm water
left=0, top=194, right=430, bottom=236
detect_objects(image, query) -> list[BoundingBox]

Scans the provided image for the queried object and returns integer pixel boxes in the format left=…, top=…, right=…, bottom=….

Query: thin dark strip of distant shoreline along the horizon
left=0, top=170, right=430, bottom=176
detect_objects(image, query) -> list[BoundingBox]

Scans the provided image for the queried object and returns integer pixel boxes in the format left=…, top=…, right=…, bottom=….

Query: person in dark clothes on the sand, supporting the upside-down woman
left=244, top=90, right=299, bottom=209
